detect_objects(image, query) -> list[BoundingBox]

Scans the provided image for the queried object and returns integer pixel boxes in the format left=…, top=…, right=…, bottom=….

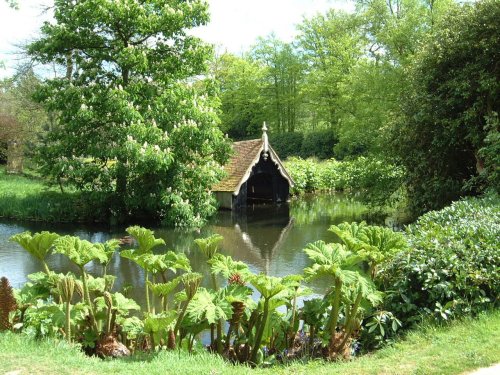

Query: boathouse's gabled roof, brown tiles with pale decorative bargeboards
left=212, top=139, right=293, bottom=195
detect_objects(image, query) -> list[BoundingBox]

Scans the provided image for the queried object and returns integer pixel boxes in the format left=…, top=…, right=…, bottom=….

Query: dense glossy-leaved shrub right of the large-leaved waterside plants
left=381, top=196, right=500, bottom=325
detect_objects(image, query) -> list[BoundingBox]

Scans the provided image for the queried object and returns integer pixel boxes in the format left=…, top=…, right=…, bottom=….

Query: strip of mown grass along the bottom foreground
left=0, top=311, right=500, bottom=375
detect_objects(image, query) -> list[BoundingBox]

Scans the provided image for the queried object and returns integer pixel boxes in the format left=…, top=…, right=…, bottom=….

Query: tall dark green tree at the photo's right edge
left=393, top=0, right=500, bottom=213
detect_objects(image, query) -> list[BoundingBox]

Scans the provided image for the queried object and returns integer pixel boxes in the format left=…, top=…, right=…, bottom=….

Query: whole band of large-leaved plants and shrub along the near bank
left=8, top=200, right=500, bottom=364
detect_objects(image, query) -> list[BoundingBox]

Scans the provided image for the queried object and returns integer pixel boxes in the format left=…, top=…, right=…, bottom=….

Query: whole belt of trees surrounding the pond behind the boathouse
left=0, top=0, right=500, bottom=225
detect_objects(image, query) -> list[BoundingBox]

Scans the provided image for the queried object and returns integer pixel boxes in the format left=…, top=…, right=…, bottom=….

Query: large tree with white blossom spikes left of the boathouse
left=28, top=0, right=229, bottom=225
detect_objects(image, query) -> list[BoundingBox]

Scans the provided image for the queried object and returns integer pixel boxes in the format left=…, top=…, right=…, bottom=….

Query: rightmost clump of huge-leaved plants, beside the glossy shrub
left=304, top=222, right=406, bottom=358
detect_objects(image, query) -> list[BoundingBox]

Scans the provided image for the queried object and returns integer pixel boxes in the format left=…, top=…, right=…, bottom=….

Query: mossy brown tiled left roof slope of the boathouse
left=212, top=139, right=263, bottom=192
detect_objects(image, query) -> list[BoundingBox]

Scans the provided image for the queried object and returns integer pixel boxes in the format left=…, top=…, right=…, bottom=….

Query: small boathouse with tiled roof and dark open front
left=212, top=123, right=293, bottom=210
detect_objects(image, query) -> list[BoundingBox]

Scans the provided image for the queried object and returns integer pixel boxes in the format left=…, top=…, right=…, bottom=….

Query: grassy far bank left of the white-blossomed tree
left=0, top=166, right=103, bottom=222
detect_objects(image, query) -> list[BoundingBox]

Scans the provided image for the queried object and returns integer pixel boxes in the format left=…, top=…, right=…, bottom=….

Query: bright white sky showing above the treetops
left=0, top=0, right=353, bottom=78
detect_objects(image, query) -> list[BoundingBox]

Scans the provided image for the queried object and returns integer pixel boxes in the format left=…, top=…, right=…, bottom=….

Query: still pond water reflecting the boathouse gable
left=0, top=195, right=386, bottom=302
